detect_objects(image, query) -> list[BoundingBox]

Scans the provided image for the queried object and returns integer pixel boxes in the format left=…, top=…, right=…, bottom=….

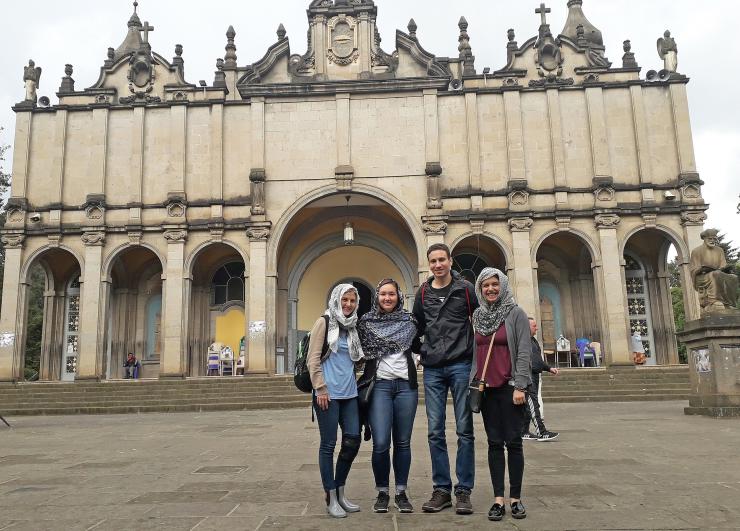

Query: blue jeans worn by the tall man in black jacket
left=424, top=361, right=475, bottom=493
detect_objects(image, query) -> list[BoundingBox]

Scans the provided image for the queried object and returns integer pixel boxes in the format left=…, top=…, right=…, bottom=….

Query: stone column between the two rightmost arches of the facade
left=596, top=214, right=632, bottom=365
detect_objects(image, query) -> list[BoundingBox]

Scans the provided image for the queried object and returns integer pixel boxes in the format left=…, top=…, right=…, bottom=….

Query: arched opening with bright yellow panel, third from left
left=187, top=243, right=248, bottom=376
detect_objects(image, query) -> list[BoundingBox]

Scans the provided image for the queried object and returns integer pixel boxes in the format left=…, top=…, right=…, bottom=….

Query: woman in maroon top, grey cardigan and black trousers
left=470, top=267, right=532, bottom=521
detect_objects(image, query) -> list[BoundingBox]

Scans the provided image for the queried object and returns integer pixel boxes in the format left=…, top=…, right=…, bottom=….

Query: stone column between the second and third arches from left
left=159, top=229, right=188, bottom=378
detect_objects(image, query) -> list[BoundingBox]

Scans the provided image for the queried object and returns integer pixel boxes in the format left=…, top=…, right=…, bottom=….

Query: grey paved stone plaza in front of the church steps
left=0, top=402, right=740, bottom=531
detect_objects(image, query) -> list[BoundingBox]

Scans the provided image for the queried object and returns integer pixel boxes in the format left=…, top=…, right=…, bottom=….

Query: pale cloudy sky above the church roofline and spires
left=0, top=0, right=740, bottom=245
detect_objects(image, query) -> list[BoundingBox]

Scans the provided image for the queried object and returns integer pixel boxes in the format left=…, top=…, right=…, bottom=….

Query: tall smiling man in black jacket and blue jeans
left=413, top=244, right=478, bottom=514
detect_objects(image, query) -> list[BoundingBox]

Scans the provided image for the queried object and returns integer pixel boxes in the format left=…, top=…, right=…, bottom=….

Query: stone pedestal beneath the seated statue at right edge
left=678, top=310, right=740, bottom=418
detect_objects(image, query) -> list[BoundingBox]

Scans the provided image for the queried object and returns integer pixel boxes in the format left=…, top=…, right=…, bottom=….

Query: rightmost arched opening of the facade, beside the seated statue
left=623, top=228, right=693, bottom=365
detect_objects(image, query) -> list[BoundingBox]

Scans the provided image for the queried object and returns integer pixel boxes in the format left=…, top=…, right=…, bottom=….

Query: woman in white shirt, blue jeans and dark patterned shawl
left=358, top=278, right=419, bottom=513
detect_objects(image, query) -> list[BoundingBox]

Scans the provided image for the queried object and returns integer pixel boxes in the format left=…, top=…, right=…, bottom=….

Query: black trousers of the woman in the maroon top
left=481, top=385, right=524, bottom=499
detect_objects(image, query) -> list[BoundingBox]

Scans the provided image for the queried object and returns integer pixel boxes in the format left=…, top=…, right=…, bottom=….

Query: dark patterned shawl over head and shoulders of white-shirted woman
left=357, top=279, right=417, bottom=359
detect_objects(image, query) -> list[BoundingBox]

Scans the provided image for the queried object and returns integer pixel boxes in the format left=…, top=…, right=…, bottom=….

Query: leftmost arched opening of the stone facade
left=21, top=248, right=82, bottom=381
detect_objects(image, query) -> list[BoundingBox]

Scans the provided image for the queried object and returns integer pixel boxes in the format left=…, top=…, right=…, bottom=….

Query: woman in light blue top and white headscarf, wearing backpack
left=307, top=284, right=363, bottom=518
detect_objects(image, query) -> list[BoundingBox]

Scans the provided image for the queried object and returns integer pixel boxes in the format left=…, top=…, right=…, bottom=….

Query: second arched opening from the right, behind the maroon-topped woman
left=536, top=232, right=604, bottom=366
